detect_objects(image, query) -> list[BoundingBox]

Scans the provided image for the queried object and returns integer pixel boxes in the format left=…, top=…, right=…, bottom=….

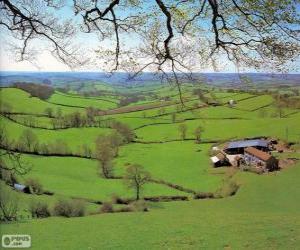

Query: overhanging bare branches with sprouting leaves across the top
left=0, top=0, right=300, bottom=102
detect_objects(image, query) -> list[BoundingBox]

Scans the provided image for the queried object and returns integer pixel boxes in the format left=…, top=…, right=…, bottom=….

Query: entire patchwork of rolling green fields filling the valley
left=0, top=83, right=300, bottom=250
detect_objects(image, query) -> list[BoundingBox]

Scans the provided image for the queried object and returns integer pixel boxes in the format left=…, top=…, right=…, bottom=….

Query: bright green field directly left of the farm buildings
left=116, top=141, right=222, bottom=192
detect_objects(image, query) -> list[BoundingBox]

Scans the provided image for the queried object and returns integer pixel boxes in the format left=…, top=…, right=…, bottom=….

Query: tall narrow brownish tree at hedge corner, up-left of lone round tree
left=95, top=136, right=115, bottom=178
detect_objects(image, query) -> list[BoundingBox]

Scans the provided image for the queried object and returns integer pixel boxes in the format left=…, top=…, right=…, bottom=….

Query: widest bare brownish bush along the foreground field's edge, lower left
left=53, top=200, right=85, bottom=217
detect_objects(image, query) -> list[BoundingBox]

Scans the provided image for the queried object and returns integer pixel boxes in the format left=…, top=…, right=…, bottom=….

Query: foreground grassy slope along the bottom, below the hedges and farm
left=2, top=165, right=300, bottom=249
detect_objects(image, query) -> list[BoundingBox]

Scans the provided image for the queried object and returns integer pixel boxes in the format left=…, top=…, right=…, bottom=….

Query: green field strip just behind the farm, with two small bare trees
left=136, top=117, right=300, bottom=141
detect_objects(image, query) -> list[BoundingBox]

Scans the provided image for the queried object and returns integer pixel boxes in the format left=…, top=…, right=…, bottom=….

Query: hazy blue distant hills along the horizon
left=0, top=71, right=300, bottom=87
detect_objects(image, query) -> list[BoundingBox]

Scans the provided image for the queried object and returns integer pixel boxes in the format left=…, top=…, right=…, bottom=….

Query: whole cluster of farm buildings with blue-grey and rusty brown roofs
left=211, top=139, right=278, bottom=171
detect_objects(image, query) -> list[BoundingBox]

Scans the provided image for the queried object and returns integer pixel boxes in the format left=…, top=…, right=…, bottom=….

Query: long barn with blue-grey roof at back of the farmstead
left=224, top=139, right=269, bottom=154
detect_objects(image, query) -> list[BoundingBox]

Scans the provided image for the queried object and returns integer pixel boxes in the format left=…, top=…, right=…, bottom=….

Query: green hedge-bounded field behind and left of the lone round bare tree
left=13, top=155, right=184, bottom=201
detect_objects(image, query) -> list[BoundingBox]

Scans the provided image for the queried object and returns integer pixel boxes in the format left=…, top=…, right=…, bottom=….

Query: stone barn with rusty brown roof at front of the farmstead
left=244, top=147, right=278, bottom=171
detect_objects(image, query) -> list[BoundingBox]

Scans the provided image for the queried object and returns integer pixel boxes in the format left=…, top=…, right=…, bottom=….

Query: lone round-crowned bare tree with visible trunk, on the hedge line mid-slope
left=124, top=164, right=150, bottom=200
